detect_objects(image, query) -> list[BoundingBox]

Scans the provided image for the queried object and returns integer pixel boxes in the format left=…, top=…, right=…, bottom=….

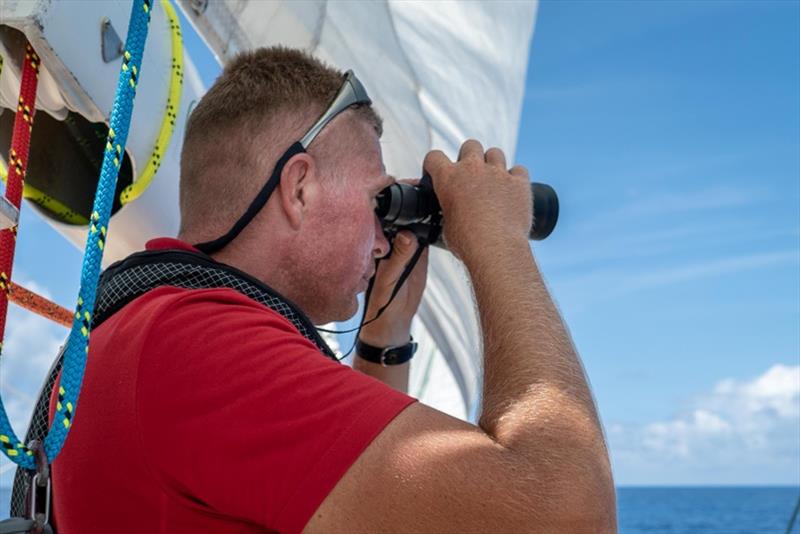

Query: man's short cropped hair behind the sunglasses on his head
left=179, top=47, right=382, bottom=237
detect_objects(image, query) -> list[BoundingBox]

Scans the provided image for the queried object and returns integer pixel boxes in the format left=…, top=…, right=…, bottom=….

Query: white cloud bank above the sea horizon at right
left=608, top=364, right=800, bottom=484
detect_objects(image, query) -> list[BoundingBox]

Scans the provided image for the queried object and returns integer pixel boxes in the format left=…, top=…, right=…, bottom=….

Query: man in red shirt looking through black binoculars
left=53, top=48, right=615, bottom=533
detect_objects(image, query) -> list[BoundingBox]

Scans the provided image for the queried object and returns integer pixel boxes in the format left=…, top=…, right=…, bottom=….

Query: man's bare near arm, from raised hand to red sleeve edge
left=306, top=142, right=615, bottom=533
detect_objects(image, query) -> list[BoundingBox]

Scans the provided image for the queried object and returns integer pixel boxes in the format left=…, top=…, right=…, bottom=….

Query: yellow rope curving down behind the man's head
left=119, top=0, right=183, bottom=205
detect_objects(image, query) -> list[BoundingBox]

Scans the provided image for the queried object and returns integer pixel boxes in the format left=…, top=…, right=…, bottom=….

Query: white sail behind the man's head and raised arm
left=180, top=0, right=537, bottom=418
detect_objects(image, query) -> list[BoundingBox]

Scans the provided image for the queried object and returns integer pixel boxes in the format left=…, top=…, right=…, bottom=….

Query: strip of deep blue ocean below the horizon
left=0, top=487, right=800, bottom=534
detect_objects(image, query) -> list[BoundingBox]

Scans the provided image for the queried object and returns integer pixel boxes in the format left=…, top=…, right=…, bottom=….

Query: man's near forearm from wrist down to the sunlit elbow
left=466, top=240, right=595, bottom=428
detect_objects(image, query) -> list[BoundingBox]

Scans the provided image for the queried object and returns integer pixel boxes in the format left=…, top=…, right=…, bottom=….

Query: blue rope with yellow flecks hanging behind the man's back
left=0, top=0, right=153, bottom=469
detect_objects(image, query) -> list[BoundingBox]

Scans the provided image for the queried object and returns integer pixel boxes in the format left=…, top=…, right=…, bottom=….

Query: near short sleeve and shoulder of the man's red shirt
left=137, top=289, right=415, bottom=533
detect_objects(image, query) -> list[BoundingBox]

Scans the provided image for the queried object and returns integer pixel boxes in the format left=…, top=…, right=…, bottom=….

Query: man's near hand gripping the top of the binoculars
left=423, top=139, right=533, bottom=260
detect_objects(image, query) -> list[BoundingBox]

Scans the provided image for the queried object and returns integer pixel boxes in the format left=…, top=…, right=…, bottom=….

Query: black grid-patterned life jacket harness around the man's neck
left=7, top=249, right=339, bottom=532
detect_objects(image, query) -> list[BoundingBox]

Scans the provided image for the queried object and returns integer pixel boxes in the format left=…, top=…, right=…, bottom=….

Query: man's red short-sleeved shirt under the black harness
left=53, top=239, right=414, bottom=534
